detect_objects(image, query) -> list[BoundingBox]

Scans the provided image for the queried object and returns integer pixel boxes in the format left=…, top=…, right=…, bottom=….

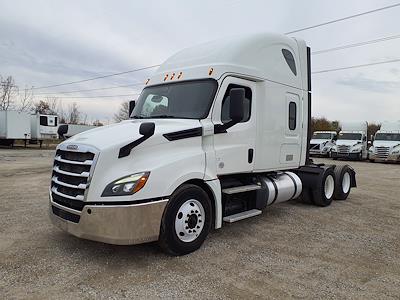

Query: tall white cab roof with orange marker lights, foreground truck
left=148, top=33, right=307, bottom=89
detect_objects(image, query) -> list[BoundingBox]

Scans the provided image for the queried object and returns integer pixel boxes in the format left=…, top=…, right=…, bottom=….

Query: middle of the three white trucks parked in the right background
left=331, top=122, right=368, bottom=160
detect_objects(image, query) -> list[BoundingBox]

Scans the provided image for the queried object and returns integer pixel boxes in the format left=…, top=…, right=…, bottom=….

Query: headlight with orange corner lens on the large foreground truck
left=101, top=172, right=150, bottom=197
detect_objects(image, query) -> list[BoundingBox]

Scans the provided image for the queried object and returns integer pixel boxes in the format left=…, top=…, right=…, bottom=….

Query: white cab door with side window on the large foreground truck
left=212, top=77, right=257, bottom=175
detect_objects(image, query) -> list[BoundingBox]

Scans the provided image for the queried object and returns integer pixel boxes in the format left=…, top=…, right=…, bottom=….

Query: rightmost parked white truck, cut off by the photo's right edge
left=369, top=121, right=400, bottom=162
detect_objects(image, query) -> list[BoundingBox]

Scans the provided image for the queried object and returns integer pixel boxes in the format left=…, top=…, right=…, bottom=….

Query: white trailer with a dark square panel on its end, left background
left=31, top=113, right=58, bottom=142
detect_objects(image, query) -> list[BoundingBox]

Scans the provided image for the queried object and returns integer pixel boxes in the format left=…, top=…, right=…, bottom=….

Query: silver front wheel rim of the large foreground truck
left=175, top=199, right=205, bottom=243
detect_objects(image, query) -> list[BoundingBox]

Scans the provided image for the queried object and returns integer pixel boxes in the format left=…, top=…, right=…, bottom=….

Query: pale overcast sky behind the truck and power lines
left=0, top=0, right=400, bottom=122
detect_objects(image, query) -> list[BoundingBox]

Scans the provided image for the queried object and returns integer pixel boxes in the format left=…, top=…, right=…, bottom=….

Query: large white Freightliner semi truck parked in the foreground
left=50, top=34, right=356, bottom=255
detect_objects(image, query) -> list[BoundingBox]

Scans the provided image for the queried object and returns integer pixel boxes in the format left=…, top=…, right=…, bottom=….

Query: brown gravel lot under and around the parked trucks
left=0, top=149, right=400, bottom=299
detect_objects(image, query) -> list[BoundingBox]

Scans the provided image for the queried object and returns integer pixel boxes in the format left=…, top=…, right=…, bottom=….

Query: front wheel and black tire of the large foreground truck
left=159, top=184, right=212, bottom=256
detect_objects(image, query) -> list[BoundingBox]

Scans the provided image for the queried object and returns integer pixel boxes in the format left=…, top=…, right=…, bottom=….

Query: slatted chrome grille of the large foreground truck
left=51, top=145, right=97, bottom=211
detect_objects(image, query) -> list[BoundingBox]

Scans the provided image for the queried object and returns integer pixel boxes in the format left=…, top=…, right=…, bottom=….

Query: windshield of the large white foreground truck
left=131, top=79, right=217, bottom=119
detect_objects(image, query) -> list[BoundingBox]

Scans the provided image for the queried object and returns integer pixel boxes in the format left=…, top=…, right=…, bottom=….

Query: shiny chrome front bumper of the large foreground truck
left=49, top=194, right=168, bottom=245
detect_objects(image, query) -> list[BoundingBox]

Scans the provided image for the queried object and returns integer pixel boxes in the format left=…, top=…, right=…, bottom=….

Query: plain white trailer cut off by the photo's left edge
left=0, top=110, right=31, bottom=145
